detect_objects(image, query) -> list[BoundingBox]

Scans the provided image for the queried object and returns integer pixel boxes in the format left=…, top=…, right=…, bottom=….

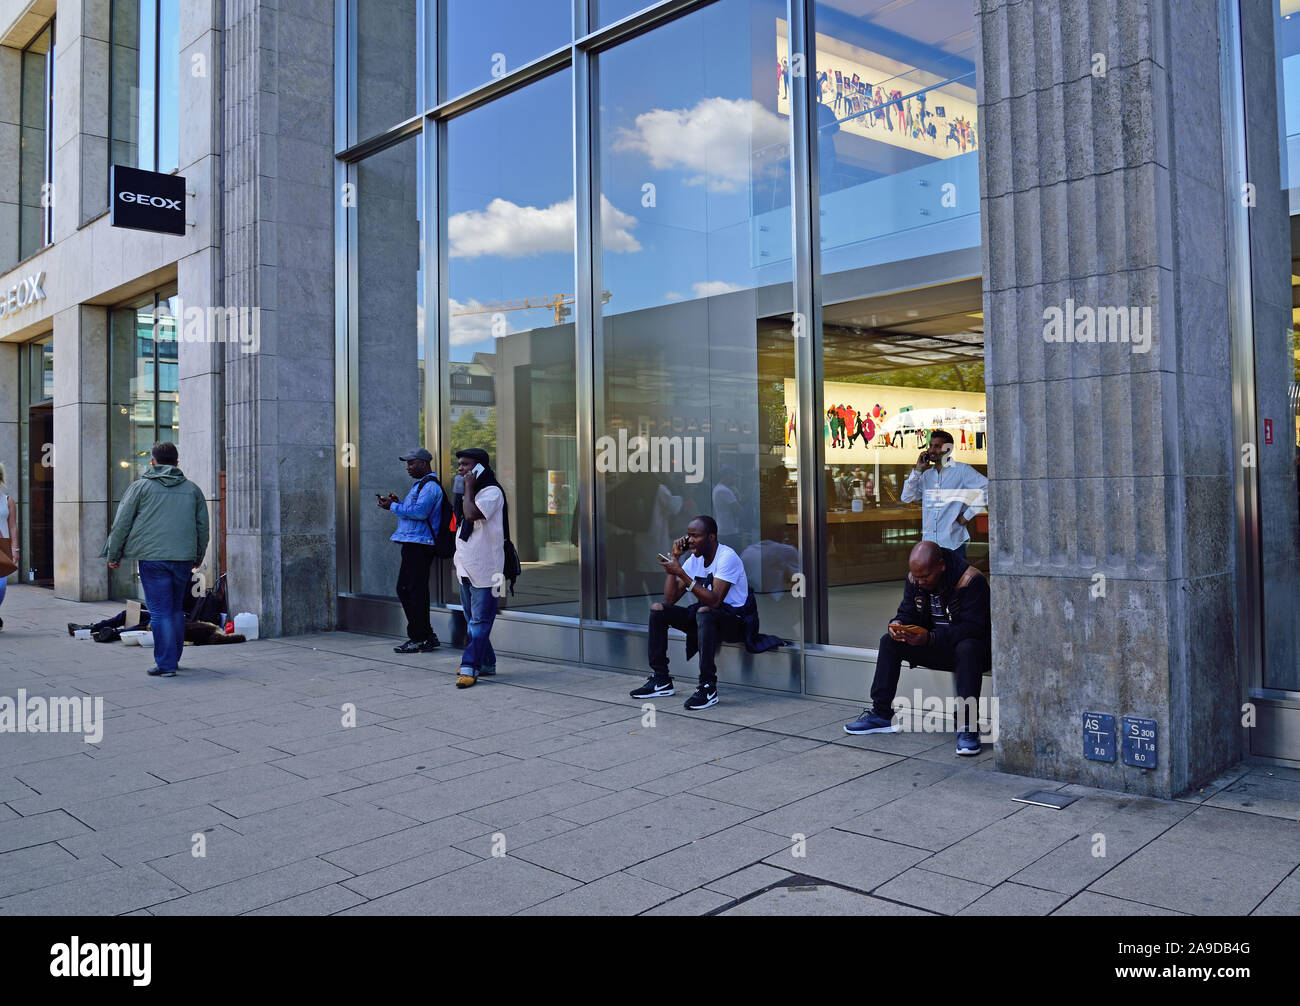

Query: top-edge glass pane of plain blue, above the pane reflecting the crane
left=430, top=0, right=573, bottom=99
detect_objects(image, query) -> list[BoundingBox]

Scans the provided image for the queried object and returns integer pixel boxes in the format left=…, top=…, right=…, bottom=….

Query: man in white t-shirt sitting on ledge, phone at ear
left=632, top=516, right=749, bottom=710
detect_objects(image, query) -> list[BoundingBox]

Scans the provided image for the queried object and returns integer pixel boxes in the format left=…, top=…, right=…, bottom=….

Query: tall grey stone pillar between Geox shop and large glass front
left=222, top=0, right=337, bottom=634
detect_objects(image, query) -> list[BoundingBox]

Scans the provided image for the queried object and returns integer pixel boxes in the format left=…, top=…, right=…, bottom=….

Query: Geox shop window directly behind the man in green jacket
left=108, top=287, right=179, bottom=598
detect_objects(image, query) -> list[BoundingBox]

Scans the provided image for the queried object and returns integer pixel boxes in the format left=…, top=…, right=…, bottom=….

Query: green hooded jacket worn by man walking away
left=100, top=464, right=208, bottom=565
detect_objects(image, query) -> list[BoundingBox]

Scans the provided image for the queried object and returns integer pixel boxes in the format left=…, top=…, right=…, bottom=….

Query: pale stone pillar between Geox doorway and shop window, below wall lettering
left=51, top=305, right=109, bottom=600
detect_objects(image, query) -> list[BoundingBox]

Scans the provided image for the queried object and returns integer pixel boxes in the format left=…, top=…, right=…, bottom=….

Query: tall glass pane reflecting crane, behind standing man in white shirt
left=441, top=68, right=579, bottom=617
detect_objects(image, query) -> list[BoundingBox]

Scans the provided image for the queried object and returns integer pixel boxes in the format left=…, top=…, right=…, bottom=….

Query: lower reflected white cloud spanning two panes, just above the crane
left=447, top=195, right=641, bottom=259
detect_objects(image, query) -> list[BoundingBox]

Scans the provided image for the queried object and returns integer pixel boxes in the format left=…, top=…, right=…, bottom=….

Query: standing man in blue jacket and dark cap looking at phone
left=378, top=447, right=442, bottom=654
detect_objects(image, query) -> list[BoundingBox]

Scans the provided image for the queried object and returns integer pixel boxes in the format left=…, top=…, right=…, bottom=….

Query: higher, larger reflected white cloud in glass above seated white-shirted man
left=614, top=97, right=788, bottom=192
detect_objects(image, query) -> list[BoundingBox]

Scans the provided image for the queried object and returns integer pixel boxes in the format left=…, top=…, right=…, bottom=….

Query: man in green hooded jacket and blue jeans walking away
left=100, top=443, right=208, bottom=677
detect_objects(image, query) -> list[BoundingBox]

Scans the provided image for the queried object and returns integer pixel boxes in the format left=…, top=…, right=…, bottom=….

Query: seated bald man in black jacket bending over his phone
left=844, top=542, right=993, bottom=755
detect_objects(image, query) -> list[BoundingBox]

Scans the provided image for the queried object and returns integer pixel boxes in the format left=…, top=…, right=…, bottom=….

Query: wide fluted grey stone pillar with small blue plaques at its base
left=976, top=0, right=1242, bottom=797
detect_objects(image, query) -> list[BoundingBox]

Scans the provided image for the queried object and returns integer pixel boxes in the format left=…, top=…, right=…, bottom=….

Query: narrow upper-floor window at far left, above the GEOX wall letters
left=18, top=21, right=55, bottom=259
